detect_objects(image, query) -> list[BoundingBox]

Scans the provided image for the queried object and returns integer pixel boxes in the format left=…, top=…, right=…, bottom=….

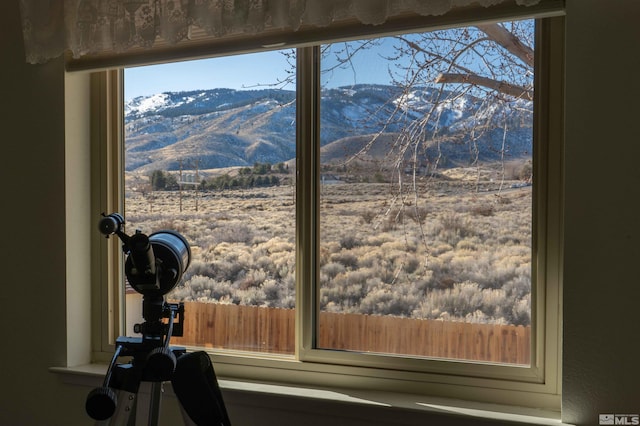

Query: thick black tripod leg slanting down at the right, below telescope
left=171, top=351, right=231, bottom=426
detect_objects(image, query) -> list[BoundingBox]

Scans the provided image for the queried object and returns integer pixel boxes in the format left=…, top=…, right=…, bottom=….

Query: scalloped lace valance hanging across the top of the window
left=20, top=0, right=540, bottom=63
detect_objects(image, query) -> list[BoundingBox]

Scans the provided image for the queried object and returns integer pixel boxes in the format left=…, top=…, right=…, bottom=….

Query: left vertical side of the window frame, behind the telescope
left=90, top=69, right=125, bottom=362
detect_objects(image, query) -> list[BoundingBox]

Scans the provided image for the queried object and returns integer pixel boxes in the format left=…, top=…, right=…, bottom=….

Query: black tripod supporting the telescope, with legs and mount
left=85, top=296, right=231, bottom=426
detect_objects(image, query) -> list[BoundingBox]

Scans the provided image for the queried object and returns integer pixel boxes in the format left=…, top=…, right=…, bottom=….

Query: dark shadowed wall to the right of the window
left=562, top=0, right=640, bottom=425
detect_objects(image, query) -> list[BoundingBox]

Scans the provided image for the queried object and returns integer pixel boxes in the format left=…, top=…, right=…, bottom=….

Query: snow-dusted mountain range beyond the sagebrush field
left=125, top=85, right=532, bottom=172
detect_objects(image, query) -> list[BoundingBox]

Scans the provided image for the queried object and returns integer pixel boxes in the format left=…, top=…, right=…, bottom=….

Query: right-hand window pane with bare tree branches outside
left=316, top=21, right=534, bottom=364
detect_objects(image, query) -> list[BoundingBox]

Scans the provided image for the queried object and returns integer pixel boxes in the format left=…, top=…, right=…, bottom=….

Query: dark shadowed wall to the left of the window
left=0, top=0, right=89, bottom=425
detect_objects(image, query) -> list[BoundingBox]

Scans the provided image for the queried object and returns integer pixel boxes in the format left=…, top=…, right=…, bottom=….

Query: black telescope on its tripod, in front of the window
left=85, top=213, right=231, bottom=426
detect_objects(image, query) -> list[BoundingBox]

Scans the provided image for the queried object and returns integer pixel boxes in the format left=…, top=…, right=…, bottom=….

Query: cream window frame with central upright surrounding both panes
left=91, top=17, right=564, bottom=410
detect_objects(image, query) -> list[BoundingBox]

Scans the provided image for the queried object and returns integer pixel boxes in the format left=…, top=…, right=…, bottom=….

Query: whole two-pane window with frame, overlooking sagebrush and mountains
left=94, top=15, right=561, bottom=407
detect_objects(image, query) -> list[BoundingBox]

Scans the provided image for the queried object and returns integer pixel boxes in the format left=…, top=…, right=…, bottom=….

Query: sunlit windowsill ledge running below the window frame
left=50, top=364, right=567, bottom=425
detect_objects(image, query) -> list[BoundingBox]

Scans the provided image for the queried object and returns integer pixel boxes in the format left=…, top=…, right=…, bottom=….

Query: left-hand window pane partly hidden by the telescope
left=125, top=52, right=296, bottom=354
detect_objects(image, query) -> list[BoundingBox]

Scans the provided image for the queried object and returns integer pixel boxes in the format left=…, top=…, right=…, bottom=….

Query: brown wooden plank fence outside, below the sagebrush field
left=172, top=302, right=531, bottom=365
